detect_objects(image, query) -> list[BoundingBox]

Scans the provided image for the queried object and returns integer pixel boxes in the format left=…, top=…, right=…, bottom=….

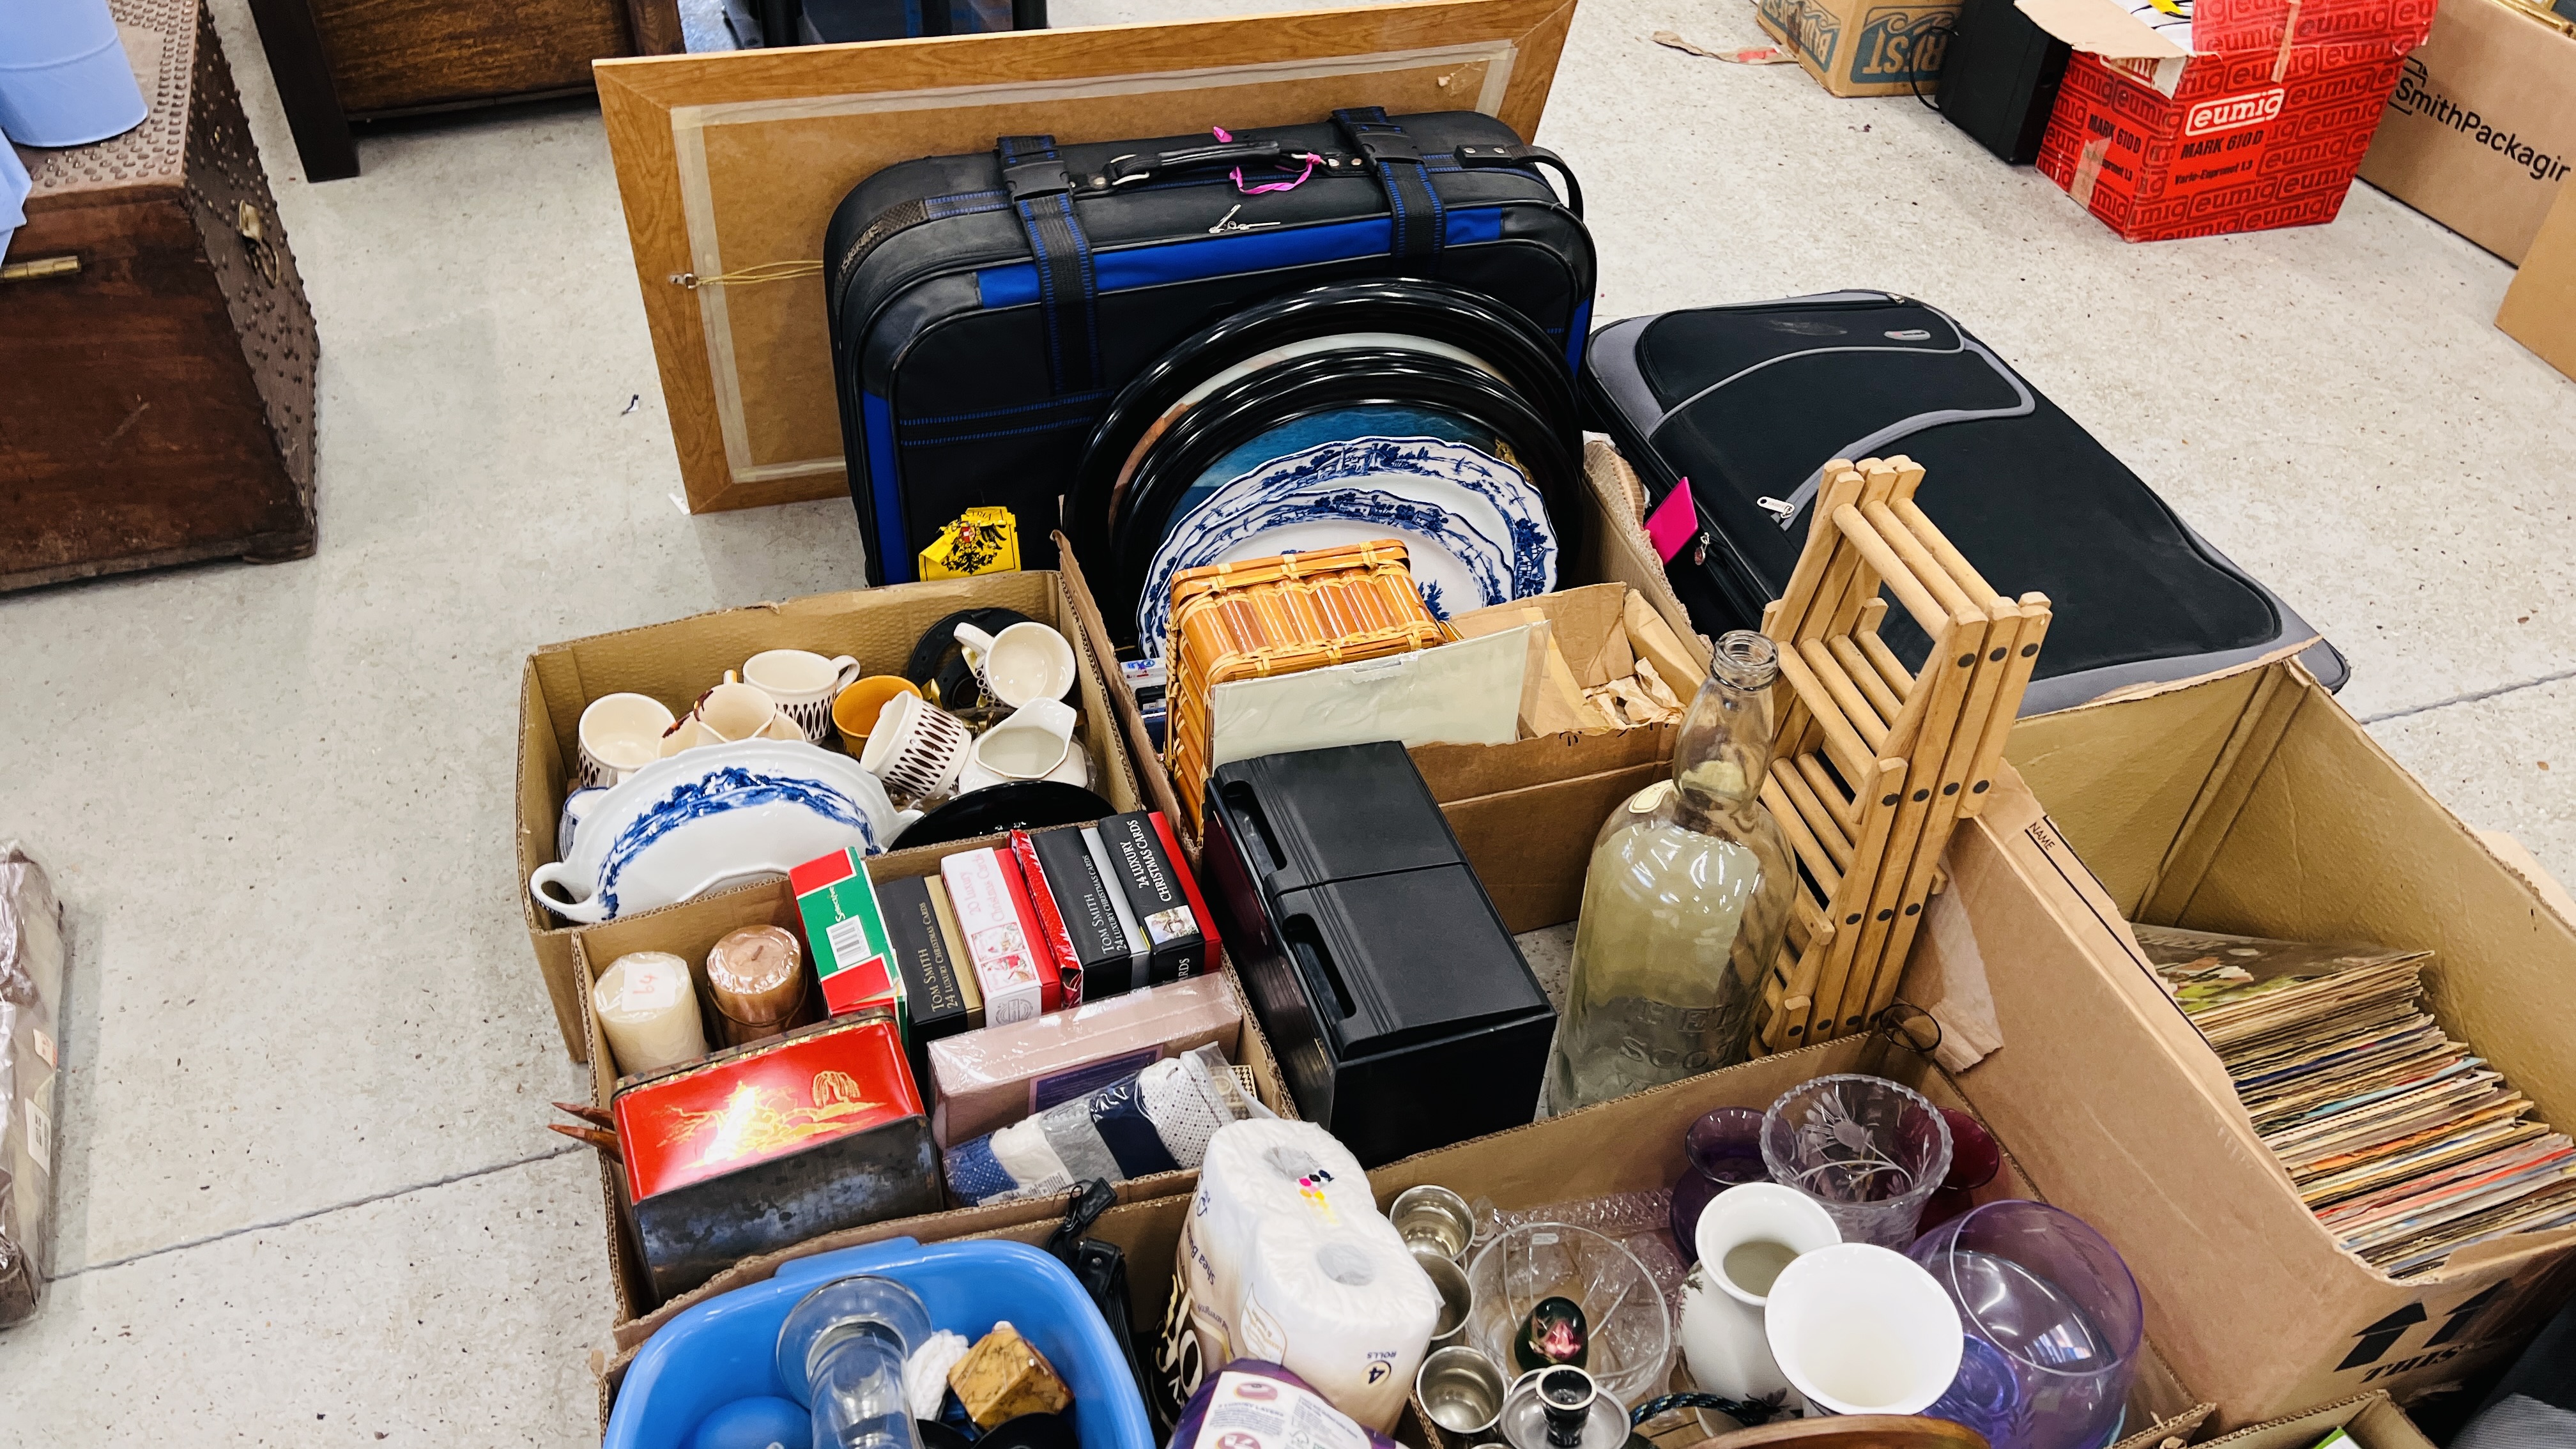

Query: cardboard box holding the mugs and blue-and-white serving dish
left=518, top=572, right=1144, bottom=1062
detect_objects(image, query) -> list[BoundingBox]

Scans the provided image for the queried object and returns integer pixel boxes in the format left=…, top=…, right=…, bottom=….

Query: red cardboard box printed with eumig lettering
left=2020, top=0, right=2434, bottom=242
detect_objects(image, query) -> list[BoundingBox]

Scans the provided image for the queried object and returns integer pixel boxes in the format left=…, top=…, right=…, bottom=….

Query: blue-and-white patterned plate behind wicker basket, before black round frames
left=1136, top=438, right=1556, bottom=657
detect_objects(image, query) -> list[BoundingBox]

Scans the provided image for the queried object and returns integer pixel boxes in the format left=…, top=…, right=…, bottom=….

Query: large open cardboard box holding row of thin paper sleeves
left=1909, top=663, right=2576, bottom=1429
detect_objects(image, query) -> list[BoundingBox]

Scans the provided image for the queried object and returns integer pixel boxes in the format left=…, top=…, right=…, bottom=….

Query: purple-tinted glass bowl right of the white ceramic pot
left=1906, top=1199, right=2146, bottom=1449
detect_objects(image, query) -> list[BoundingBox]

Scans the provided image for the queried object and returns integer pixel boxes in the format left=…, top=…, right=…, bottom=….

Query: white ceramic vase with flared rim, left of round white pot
left=1682, top=1183, right=1842, bottom=1400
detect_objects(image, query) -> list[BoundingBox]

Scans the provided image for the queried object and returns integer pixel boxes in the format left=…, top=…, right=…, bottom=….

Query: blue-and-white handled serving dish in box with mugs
left=528, top=740, right=917, bottom=926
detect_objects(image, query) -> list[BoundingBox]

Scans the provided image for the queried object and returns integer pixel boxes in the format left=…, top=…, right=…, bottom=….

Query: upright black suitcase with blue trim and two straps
left=824, top=108, right=1592, bottom=583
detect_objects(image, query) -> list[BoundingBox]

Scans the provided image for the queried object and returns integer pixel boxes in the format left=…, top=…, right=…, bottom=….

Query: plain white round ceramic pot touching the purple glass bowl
left=1761, top=1238, right=1965, bottom=1413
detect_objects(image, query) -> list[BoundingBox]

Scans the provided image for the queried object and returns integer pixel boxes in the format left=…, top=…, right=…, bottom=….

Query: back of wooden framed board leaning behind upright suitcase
left=595, top=0, right=1574, bottom=513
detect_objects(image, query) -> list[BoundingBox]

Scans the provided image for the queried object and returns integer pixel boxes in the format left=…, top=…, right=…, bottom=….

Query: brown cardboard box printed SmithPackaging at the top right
left=2362, top=0, right=2576, bottom=266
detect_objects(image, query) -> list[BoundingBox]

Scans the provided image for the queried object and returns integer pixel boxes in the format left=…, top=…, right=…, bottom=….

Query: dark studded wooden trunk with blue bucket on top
left=0, top=0, right=314, bottom=590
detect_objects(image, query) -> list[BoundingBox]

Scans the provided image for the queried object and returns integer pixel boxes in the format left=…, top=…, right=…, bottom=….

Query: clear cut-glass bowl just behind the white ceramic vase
left=1762, top=1073, right=1950, bottom=1253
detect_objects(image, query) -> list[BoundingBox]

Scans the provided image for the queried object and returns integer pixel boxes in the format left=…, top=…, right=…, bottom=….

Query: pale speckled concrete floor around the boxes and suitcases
left=0, top=0, right=2576, bottom=1446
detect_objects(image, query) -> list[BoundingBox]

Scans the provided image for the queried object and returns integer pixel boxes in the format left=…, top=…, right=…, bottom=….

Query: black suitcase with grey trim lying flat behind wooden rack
left=1579, top=291, right=2349, bottom=714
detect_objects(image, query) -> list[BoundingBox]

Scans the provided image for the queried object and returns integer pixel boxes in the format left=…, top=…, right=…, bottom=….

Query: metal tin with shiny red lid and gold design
left=611, top=1013, right=940, bottom=1297
